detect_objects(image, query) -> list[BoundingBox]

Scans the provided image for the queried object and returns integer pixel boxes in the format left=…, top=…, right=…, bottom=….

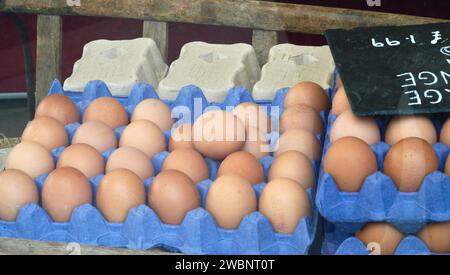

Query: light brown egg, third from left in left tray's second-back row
left=119, top=120, right=166, bottom=157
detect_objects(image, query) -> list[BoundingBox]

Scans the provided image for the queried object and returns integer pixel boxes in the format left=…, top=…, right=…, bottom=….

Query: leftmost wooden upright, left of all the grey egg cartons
left=36, top=15, right=62, bottom=104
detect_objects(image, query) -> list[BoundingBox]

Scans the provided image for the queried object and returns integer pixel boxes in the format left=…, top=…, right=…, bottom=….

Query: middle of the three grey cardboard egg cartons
left=158, top=42, right=260, bottom=102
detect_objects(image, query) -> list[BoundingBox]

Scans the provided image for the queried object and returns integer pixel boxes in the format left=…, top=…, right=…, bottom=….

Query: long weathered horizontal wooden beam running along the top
left=0, top=0, right=447, bottom=34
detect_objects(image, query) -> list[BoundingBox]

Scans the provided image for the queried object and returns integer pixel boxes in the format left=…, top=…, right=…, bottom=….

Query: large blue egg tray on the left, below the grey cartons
left=0, top=81, right=327, bottom=254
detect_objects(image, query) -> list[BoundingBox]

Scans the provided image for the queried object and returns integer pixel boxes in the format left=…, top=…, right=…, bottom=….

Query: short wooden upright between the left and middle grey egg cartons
left=143, top=21, right=169, bottom=62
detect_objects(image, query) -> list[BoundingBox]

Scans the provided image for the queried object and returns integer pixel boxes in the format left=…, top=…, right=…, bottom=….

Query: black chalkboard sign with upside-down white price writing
left=325, top=23, right=450, bottom=116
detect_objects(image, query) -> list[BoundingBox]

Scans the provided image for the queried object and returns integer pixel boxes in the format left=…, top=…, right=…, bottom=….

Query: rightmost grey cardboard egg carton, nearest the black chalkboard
left=253, top=44, right=335, bottom=100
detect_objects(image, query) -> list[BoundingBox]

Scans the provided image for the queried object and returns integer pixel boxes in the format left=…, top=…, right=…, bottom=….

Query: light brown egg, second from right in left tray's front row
left=206, top=174, right=257, bottom=229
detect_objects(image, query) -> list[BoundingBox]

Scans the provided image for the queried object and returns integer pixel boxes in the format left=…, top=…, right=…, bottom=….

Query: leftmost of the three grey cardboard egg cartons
left=64, top=38, right=168, bottom=96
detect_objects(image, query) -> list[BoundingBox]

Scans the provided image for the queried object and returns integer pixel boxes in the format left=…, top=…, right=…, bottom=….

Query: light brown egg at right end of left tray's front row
left=259, top=178, right=311, bottom=234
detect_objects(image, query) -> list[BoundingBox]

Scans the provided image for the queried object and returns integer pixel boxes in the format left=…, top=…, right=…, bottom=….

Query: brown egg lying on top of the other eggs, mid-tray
left=193, top=110, right=245, bottom=160
